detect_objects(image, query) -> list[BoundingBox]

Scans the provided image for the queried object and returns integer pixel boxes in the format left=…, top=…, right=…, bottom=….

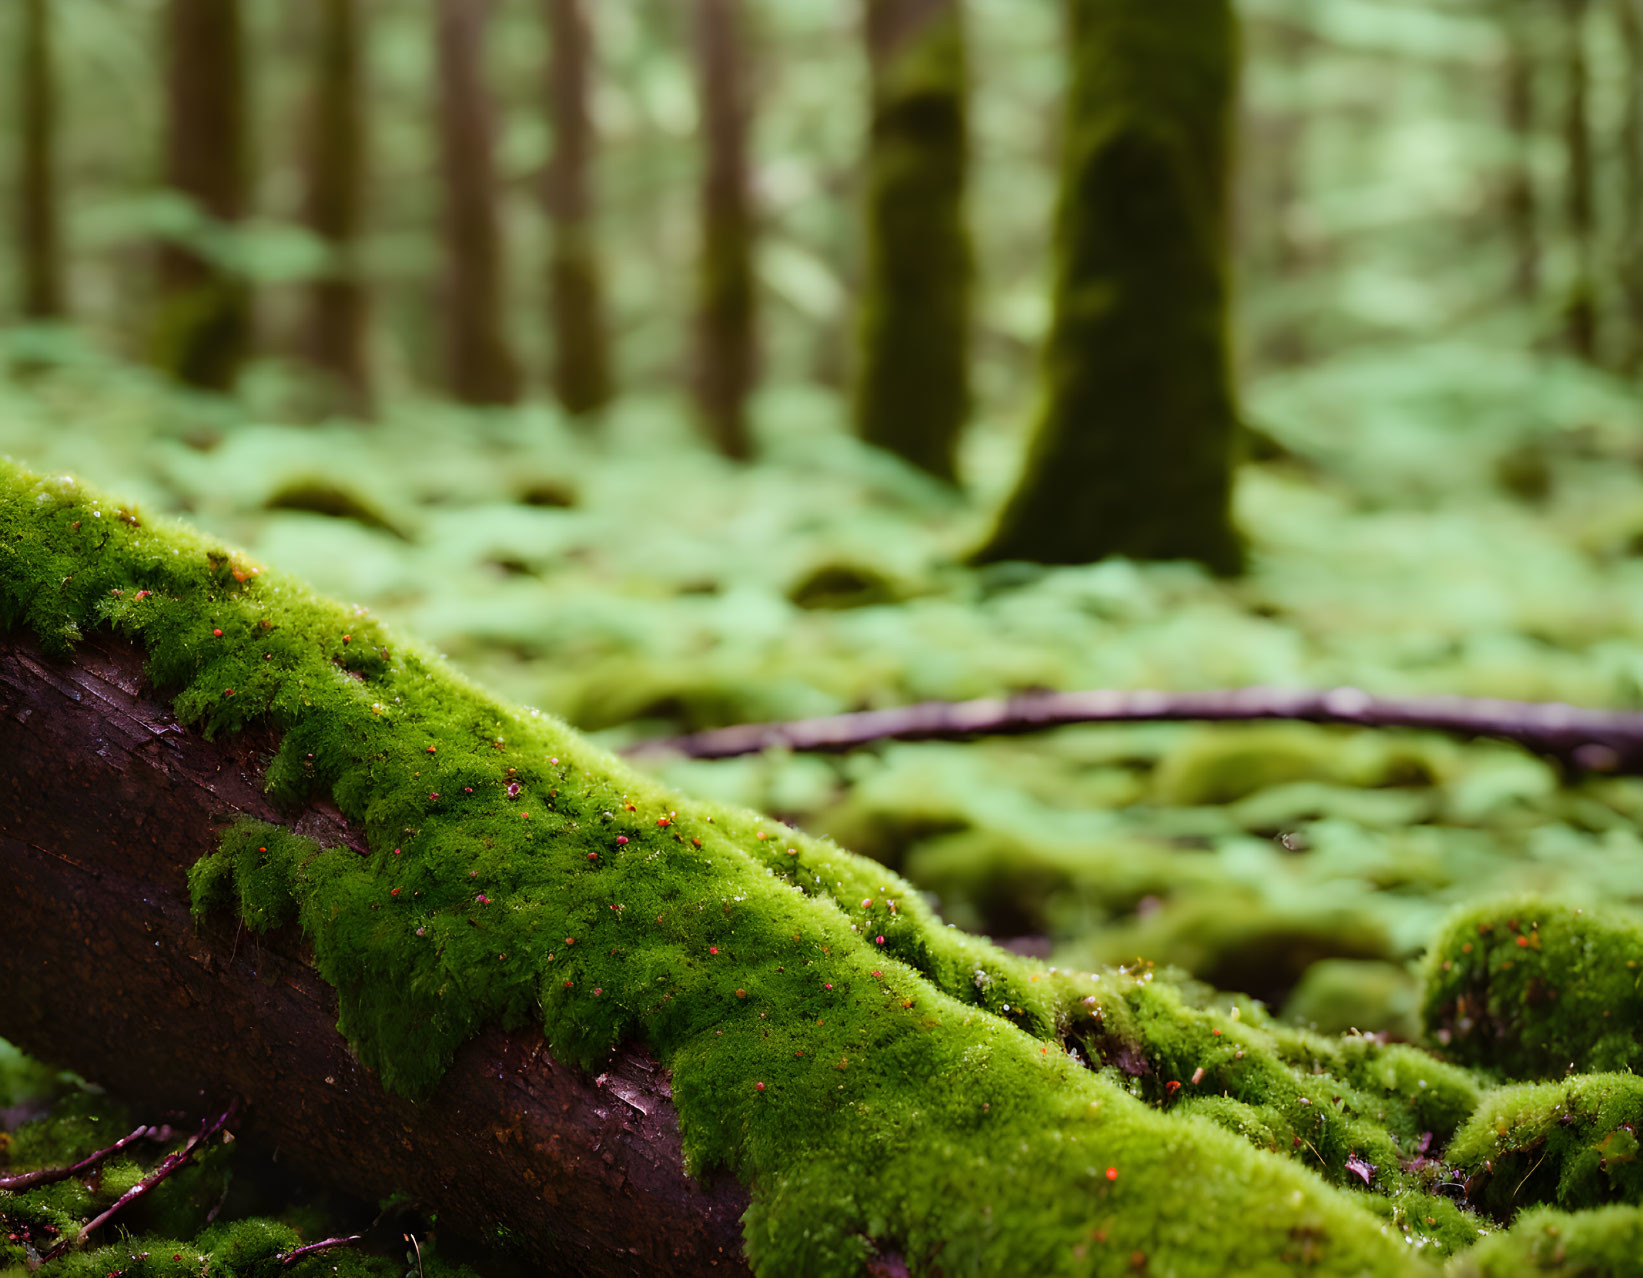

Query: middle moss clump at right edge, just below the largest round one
left=1449, top=1074, right=1643, bottom=1219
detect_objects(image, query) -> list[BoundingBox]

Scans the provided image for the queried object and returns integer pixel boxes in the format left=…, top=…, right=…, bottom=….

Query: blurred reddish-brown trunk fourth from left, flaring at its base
left=437, top=0, right=519, bottom=404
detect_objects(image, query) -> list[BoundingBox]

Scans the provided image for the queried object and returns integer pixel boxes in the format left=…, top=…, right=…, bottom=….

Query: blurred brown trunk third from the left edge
left=306, top=0, right=371, bottom=417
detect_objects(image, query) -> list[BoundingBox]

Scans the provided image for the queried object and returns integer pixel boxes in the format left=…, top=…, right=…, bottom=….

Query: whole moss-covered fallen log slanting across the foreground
left=0, top=463, right=1464, bottom=1275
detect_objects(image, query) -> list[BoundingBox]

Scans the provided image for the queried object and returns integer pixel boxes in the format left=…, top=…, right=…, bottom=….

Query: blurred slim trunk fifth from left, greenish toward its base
left=545, top=0, right=611, bottom=416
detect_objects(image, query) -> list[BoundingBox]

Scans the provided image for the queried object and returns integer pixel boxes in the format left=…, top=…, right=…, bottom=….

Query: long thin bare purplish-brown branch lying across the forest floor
left=628, top=688, right=1643, bottom=777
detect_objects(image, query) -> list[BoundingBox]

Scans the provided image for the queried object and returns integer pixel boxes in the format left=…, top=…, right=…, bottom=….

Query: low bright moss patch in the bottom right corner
left=1451, top=1206, right=1643, bottom=1278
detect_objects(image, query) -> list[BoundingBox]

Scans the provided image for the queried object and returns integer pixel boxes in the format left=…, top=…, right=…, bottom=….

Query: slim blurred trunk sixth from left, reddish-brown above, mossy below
left=695, top=0, right=754, bottom=458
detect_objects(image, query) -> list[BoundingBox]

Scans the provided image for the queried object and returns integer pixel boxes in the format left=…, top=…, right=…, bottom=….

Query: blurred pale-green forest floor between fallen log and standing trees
left=0, top=328, right=1643, bottom=1037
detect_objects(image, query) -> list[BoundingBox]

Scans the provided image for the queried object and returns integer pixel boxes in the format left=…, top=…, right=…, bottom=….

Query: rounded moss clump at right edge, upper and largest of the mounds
left=1421, top=899, right=1643, bottom=1079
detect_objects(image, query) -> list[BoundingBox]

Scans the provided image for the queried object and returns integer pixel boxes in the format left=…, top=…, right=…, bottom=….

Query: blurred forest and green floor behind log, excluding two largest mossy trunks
left=0, top=0, right=1643, bottom=1261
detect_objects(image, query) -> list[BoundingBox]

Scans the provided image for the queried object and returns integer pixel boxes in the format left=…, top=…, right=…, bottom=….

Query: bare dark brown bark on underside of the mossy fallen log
left=0, top=636, right=748, bottom=1275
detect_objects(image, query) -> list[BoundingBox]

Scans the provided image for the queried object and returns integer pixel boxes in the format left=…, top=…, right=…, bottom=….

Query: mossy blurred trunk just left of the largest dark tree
left=856, top=0, right=971, bottom=481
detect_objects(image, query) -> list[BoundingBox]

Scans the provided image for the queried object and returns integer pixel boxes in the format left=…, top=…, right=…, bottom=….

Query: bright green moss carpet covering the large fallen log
left=0, top=465, right=1443, bottom=1275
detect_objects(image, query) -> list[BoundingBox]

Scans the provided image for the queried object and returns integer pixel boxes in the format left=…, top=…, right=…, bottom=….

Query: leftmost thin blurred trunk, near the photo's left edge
left=16, top=0, right=62, bottom=320
